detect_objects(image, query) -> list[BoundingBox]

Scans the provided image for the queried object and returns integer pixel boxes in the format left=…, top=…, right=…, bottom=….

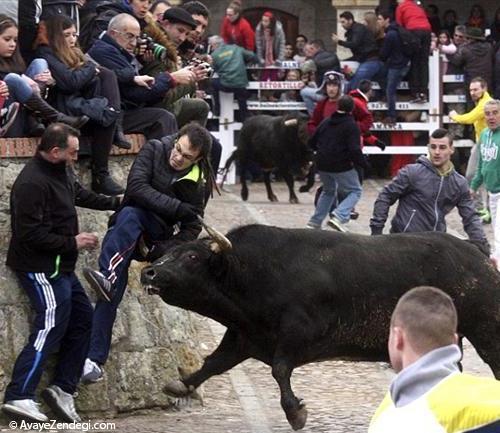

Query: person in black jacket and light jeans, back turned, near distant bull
left=307, top=96, right=366, bottom=232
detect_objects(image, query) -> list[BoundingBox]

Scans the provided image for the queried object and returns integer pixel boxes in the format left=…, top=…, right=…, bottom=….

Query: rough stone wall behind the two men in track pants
left=0, top=150, right=201, bottom=417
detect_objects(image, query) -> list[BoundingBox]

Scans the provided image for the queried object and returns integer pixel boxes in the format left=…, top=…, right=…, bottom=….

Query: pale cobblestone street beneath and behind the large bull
left=0, top=180, right=492, bottom=433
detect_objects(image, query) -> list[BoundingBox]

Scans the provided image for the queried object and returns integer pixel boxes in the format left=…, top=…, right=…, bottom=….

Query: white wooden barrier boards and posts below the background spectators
left=214, top=53, right=473, bottom=184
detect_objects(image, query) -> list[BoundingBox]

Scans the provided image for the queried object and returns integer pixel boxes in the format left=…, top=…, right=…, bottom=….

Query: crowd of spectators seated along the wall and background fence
left=0, top=0, right=500, bottom=176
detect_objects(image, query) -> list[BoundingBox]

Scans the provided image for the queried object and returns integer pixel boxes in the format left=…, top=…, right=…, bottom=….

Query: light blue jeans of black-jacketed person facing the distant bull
left=309, top=168, right=362, bottom=227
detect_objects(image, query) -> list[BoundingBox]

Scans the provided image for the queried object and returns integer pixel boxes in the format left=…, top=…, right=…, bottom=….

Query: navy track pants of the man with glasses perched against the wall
left=88, top=206, right=174, bottom=364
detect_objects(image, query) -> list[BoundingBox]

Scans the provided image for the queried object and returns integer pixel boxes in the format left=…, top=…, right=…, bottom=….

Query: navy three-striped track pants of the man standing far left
left=4, top=272, right=92, bottom=401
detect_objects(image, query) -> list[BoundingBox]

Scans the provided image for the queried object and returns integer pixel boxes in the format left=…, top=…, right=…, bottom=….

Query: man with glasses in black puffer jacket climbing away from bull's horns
left=82, top=123, right=212, bottom=382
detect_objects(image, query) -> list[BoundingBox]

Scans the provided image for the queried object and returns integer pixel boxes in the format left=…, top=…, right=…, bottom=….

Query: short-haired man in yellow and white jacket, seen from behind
left=368, top=287, right=500, bottom=433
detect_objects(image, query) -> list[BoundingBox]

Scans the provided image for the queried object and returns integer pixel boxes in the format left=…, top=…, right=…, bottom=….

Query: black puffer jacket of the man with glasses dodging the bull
left=122, top=134, right=205, bottom=241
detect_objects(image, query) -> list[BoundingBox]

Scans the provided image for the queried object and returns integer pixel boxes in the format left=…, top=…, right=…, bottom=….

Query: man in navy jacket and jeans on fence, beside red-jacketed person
left=378, top=10, right=410, bottom=124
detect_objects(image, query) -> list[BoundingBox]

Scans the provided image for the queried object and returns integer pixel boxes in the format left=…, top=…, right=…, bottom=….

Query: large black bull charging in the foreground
left=141, top=225, right=500, bottom=429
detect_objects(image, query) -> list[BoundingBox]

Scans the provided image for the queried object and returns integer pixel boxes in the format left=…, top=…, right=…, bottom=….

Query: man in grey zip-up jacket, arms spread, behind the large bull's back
left=370, top=129, right=489, bottom=254
